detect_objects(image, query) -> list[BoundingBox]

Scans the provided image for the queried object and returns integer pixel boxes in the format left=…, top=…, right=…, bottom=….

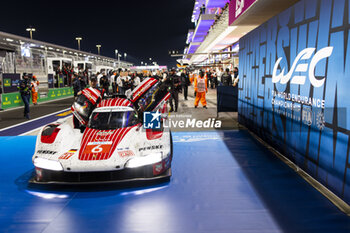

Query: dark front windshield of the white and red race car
left=89, top=111, right=138, bottom=130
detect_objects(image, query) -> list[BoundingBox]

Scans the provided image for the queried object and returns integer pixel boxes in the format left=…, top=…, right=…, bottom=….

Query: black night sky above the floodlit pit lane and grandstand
left=0, top=0, right=194, bottom=66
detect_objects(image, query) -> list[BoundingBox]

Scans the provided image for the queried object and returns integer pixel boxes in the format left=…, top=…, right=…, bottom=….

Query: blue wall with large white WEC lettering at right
left=238, top=0, right=350, bottom=204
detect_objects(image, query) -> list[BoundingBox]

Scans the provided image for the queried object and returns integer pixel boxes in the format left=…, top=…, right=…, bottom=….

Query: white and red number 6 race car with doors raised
left=31, top=78, right=172, bottom=184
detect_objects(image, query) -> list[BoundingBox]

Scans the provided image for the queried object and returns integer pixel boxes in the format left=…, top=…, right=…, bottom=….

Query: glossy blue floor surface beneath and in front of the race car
left=0, top=131, right=349, bottom=233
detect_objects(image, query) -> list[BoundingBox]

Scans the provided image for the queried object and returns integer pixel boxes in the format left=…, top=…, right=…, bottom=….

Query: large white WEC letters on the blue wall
left=272, top=47, right=333, bottom=87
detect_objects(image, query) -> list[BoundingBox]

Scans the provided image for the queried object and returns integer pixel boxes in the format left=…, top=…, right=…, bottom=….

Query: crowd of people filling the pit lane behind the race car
left=73, top=67, right=239, bottom=112
